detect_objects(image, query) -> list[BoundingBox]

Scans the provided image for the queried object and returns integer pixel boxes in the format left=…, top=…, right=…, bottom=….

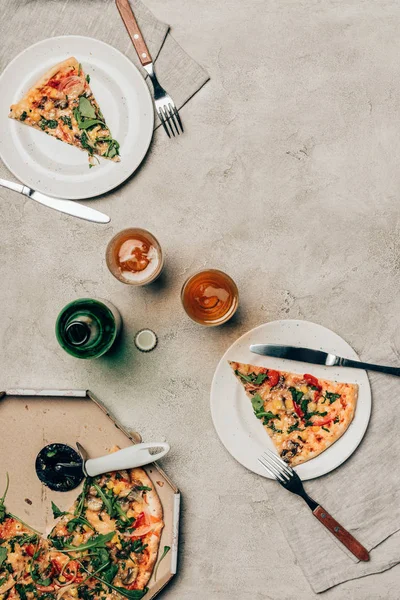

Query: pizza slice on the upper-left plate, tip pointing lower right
left=9, top=57, right=120, bottom=166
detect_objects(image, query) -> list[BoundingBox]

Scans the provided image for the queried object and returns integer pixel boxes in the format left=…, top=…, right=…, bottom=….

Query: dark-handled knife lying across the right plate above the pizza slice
left=250, top=344, right=400, bottom=377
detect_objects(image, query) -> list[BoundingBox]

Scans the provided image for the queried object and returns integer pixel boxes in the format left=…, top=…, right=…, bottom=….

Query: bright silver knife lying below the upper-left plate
left=0, top=179, right=111, bottom=223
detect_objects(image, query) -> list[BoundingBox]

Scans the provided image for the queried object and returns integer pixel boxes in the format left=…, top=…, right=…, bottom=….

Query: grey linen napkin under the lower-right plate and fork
left=267, top=364, right=400, bottom=592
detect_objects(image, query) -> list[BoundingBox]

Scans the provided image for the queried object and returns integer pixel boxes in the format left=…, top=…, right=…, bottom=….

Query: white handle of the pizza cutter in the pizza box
left=85, top=442, right=169, bottom=477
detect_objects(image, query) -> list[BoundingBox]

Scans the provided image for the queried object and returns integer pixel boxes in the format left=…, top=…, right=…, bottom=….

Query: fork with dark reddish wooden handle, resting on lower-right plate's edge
left=258, top=450, right=369, bottom=561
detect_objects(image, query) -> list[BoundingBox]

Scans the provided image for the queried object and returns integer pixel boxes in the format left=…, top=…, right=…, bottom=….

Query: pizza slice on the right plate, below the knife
left=230, top=362, right=358, bottom=466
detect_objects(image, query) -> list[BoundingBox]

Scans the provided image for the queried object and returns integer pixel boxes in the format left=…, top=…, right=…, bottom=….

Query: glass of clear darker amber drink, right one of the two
left=182, top=269, right=239, bottom=325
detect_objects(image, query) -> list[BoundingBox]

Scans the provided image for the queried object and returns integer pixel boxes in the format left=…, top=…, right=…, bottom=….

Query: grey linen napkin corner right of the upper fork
left=126, top=0, right=210, bottom=128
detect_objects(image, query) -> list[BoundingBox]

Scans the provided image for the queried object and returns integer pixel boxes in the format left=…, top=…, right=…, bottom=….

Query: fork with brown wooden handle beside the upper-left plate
left=115, top=0, right=183, bottom=138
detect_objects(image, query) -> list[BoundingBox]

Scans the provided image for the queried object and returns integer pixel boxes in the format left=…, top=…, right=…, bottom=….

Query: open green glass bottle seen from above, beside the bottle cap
left=56, top=298, right=121, bottom=358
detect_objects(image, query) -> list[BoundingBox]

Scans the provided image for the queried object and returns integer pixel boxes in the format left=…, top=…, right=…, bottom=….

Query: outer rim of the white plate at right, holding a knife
left=210, top=319, right=372, bottom=481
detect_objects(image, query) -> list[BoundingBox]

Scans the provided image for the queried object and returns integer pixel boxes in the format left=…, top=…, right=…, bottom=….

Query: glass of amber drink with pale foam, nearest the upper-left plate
left=106, top=227, right=164, bottom=285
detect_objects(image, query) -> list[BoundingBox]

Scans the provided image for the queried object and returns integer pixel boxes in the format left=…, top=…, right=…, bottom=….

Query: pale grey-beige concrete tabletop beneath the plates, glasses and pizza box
left=0, top=0, right=400, bottom=600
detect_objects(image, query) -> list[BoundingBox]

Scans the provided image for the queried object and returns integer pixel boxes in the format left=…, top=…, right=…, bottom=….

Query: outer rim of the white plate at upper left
left=0, top=34, right=154, bottom=200
